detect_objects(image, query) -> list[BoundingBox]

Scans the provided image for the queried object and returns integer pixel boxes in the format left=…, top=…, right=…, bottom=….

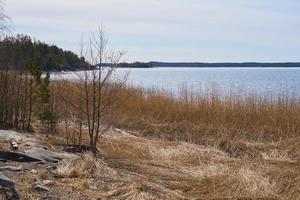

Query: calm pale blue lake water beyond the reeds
left=54, top=67, right=300, bottom=97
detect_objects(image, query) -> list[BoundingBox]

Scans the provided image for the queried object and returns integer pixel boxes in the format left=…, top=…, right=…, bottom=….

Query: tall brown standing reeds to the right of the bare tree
left=112, top=84, right=300, bottom=144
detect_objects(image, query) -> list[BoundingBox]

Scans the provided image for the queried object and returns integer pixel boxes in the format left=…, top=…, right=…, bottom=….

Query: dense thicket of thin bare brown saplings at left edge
left=0, top=67, right=34, bottom=131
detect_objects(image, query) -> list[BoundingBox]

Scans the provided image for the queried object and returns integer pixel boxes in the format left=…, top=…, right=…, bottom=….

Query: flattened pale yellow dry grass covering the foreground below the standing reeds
left=50, top=131, right=300, bottom=200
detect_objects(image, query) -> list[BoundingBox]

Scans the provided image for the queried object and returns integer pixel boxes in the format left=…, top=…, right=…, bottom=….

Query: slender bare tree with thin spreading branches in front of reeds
left=77, top=27, right=126, bottom=154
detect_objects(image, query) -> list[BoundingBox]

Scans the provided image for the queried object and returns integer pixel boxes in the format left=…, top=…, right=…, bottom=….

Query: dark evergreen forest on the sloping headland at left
left=0, top=35, right=89, bottom=71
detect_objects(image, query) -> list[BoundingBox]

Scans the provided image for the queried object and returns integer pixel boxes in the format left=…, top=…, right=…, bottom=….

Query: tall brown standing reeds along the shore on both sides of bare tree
left=52, top=81, right=300, bottom=158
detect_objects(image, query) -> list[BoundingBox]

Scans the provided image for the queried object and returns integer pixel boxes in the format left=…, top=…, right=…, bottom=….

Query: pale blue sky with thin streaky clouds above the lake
left=5, top=0, right=300, bottom=62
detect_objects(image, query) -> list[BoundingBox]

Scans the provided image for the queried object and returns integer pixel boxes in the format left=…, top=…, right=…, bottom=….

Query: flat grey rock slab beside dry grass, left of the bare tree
left=25, top=148, right=63, bottom=163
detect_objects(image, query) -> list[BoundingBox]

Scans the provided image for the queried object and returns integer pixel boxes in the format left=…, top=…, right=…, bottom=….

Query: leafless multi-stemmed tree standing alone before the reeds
left=79, top=28, right=122, bottom=154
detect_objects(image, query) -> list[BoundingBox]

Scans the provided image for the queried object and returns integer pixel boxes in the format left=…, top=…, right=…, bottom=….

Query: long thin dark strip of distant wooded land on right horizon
left=149, top=62, right=300, bottom=67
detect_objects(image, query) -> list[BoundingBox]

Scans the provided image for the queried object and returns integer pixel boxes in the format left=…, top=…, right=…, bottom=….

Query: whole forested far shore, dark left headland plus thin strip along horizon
left=0, top=34, right=300, bottom=71
